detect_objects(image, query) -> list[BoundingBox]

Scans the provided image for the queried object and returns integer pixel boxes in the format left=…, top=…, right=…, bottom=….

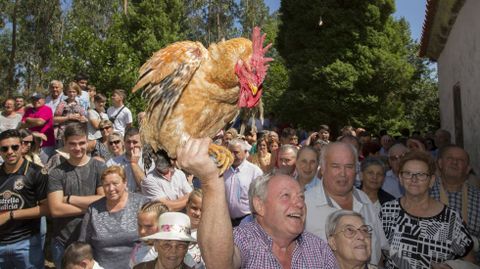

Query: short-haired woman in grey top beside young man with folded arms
left=79, top=165, right=146, bottom=269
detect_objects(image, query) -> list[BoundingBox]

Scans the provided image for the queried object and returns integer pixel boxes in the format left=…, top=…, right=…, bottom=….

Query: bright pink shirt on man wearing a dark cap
left=22, top=105, right=55, bottom=147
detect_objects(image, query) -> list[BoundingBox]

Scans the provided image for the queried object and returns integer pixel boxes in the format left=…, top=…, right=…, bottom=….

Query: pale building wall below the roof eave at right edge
left=438, top=0, right=480, bottom=175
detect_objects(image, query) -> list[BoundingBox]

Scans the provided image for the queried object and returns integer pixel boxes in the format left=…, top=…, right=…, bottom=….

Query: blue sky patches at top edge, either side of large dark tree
left=265, top=0, right=426, bottom=42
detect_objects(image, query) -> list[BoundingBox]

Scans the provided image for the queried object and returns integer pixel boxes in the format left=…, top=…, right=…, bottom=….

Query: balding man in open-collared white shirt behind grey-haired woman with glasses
left=305, top=142, right=388, bottom=265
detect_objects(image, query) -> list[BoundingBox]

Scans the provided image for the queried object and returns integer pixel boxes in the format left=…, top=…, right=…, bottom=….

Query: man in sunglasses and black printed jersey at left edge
left=0, top=130, right=48, bottom=268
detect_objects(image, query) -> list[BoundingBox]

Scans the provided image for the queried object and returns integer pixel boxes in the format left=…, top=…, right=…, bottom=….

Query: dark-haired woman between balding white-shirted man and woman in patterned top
left=360, top=157, right=395, bottom=213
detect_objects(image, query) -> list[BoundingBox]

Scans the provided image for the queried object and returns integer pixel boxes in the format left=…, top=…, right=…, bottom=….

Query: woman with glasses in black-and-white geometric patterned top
left=380, top=151, right=473, bottom=269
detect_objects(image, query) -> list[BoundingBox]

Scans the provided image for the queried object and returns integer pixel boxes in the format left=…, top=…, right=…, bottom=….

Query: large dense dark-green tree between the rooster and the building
left=277, top=0, right=438, bottom=132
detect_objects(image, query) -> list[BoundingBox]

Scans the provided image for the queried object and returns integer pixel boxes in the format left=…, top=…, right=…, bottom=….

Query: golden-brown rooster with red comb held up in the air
left=132, top=27, right=272, bottom=173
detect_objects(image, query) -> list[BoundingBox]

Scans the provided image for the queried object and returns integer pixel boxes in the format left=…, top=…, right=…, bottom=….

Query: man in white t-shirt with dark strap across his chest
left=107, top=89, right=133, bottom=135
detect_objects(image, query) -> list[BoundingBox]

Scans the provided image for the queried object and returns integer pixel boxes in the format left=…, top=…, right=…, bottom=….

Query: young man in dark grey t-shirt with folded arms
left=48, top=123, right=105, bottom=269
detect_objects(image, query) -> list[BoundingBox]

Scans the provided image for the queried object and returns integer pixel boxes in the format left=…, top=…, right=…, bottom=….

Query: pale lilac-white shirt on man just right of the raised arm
left=223, top=160, right=263, bottom=219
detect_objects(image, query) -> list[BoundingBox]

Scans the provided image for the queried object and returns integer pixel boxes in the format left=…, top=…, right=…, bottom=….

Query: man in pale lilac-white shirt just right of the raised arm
left=223, top=139, right=263, bottom=226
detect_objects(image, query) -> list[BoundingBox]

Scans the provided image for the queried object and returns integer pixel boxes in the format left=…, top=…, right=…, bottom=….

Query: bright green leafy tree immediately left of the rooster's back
left=44, top=0, right=185, bottom=116
